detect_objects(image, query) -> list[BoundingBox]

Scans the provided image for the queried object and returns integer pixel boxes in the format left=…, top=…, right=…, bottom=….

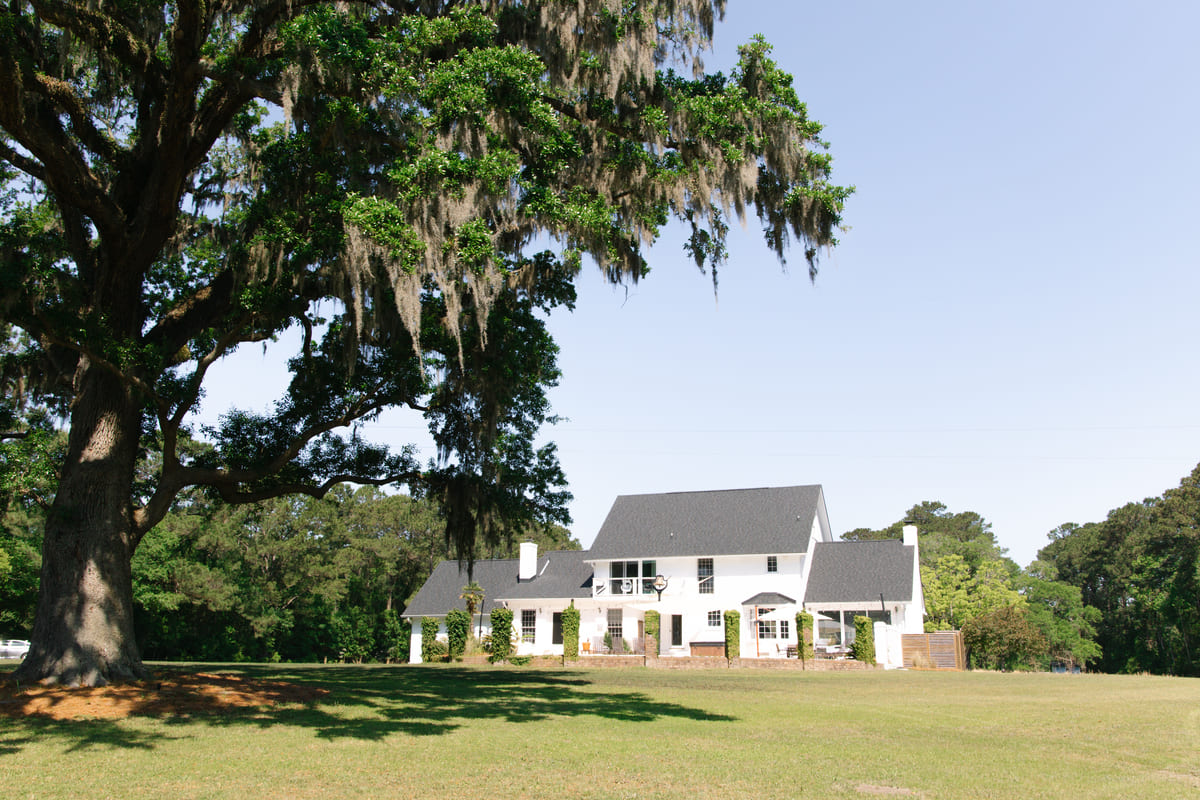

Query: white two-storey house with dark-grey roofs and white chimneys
left=403, top=486, right=924, bottom=662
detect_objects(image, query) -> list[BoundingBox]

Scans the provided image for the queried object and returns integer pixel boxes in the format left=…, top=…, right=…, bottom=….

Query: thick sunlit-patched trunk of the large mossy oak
left=17, top=357, right=146, bottom=686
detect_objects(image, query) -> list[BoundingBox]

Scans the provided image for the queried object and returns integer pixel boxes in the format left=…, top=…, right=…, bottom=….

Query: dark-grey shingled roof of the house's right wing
left=804, top=539, right=917, bottom=608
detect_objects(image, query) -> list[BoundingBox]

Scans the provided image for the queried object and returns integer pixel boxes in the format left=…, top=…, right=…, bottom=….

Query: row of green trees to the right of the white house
left=842, top=467, right=1200, bottom=676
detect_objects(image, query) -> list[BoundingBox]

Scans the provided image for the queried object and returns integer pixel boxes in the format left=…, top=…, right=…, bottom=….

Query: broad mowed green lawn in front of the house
left=0, top=666, right=1200, bottom=800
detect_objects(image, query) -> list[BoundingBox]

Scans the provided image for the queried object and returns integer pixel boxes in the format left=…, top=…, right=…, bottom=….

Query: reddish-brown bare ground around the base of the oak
left=0, top=673, right=329, bottom=720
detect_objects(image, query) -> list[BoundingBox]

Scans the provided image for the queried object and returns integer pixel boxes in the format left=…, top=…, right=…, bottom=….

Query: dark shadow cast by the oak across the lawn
left=0, top=664, right=736, bottom=754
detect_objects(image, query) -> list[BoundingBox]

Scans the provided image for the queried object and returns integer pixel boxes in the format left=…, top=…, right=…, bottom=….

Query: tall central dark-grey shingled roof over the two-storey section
left=588, top=485, right=824, bottom=561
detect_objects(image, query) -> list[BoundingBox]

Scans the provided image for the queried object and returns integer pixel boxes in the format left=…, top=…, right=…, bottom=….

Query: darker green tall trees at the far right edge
left=1038, top=467, right=1200, bottom=676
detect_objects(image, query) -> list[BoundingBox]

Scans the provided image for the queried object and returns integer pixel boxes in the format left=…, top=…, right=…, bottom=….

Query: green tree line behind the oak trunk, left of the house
left=0, top=462, right=580, bottom=662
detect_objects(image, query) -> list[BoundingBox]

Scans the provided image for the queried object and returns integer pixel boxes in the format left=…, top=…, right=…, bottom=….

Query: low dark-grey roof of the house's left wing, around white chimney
left=401, top=551, right=592, bottom=618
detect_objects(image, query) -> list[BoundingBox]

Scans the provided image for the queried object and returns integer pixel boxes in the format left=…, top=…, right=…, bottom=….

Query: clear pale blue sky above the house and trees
left=196, top=0, right=1200, bottom=565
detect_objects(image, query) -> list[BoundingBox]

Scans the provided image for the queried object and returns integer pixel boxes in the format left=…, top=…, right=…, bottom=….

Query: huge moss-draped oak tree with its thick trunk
left=0, top=0, right=850, bottom=684
